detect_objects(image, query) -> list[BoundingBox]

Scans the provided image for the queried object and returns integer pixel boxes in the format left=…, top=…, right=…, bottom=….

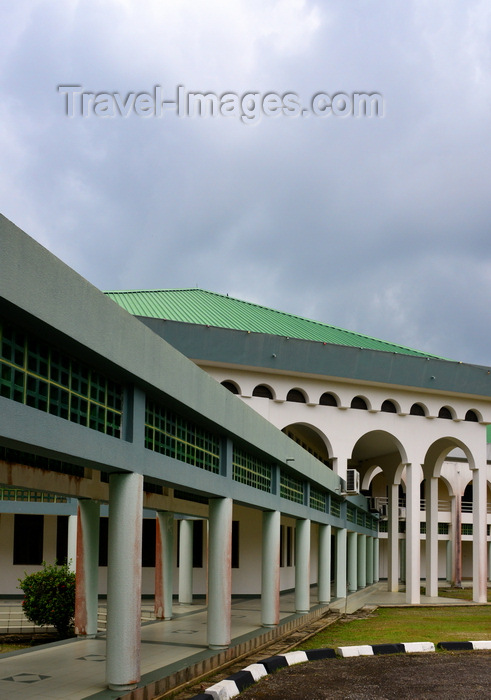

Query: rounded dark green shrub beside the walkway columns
left=19, top=562, right=75, bottom=638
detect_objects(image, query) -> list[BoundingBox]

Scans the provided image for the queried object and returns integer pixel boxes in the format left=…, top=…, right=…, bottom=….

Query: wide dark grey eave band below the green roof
left=139, top=317, right=491, bottom=398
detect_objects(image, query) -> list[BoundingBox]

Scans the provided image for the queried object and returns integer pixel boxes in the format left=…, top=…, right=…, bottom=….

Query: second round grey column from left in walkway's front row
left=208, top=498, right=233, bottom=649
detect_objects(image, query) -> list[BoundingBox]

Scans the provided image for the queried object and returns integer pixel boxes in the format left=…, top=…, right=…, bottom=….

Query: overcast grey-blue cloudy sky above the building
left=0, top=0, right=491, bottom=365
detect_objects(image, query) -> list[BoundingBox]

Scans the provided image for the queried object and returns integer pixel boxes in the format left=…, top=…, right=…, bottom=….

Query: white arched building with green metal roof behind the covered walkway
left=108, top=289, right=491, bottom=602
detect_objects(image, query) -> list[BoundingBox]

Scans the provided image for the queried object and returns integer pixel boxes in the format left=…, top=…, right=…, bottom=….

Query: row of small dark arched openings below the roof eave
left=222, top=380, right=482, bottom=423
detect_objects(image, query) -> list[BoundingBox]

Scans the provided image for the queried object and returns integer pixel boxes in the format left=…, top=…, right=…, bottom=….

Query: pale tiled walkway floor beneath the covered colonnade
left=0, top=583, right=476, bottom=700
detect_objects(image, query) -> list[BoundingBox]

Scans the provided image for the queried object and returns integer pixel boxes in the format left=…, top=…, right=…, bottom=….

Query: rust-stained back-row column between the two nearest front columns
left=154, top=511, right=174, bottom=620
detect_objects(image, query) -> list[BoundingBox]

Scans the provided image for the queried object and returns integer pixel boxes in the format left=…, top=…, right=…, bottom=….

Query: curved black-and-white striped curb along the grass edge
left=190, top=641, right=491, bottom=700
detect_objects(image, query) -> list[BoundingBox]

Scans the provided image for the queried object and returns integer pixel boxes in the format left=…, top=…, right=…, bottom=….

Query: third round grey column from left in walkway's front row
left=261, top=510, right=281, bottom=627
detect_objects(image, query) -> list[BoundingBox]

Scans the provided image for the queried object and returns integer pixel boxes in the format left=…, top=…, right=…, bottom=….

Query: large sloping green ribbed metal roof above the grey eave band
left=106, top=289, right=442, bottom=359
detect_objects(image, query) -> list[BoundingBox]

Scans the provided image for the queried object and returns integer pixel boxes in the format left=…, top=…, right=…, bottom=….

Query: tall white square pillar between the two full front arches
left=406, top=463, right=421, bottom=605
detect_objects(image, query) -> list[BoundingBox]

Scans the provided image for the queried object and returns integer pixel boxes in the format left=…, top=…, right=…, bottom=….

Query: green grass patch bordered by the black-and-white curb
left=298, top=606, right=491, bottom=649
